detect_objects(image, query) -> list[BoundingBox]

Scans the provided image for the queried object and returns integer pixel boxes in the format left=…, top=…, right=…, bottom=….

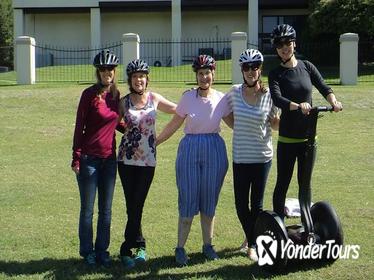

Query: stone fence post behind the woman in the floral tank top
left=122, top=33, right=140, bottom=81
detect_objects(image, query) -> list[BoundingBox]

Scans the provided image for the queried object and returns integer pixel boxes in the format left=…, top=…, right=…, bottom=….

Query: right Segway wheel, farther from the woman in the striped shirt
left=310, top=201, right=344, bottom=261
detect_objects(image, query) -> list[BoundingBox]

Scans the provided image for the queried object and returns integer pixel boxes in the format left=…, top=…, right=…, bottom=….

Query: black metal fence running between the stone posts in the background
left=0, top=38, right=374, bottom=83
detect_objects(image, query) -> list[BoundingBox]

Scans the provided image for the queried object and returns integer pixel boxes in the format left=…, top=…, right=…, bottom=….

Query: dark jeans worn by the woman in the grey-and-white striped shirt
left=233, top=160, right=271, bottom=246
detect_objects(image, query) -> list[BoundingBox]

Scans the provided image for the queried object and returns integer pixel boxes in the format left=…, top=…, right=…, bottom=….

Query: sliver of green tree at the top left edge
left=0, top=0, right=13, bottom=68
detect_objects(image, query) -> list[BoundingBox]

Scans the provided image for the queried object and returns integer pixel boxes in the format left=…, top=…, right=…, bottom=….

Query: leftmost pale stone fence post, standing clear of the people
left=16, top=36, right=35, bottom=85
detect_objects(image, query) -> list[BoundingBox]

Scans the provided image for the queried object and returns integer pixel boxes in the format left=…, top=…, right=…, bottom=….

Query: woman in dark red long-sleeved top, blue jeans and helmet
left=71, top=50, right=125, bottom=266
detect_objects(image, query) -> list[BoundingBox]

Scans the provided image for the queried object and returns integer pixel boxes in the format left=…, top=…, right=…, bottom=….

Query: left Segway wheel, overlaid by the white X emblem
left=254, top=211, right=288, bottom=271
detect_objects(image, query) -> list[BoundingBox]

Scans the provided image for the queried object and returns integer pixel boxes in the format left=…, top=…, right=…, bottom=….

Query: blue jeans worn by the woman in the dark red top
left=77, top=155, right=117, bottom=258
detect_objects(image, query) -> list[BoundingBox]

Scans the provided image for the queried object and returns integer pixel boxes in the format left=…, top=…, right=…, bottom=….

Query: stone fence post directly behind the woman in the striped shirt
left=231, top=32, right=247, bottom=84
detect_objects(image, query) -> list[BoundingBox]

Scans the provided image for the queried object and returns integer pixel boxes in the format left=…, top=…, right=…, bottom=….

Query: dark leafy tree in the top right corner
left=309, top=0, right=374, bottom=39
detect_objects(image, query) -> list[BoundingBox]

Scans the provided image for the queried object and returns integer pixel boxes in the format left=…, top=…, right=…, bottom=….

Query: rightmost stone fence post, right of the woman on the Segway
left=339, top=33, right=359, bottom=85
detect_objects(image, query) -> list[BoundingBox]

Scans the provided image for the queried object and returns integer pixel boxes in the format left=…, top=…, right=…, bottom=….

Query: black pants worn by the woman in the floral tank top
left=118, top=163, right=155, bottom=256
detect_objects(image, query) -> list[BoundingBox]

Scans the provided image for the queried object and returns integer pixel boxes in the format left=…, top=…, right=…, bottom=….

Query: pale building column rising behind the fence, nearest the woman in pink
left=171, top=0, right=182, bottom=66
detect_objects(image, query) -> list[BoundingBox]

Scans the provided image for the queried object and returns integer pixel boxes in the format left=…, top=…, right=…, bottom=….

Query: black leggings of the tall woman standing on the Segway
left=273, top=142, right=317, bottom=232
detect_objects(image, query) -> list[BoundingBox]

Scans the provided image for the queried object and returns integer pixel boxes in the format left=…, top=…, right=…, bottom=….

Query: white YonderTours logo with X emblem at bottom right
left=256, top=231, right=360, bottom=266
